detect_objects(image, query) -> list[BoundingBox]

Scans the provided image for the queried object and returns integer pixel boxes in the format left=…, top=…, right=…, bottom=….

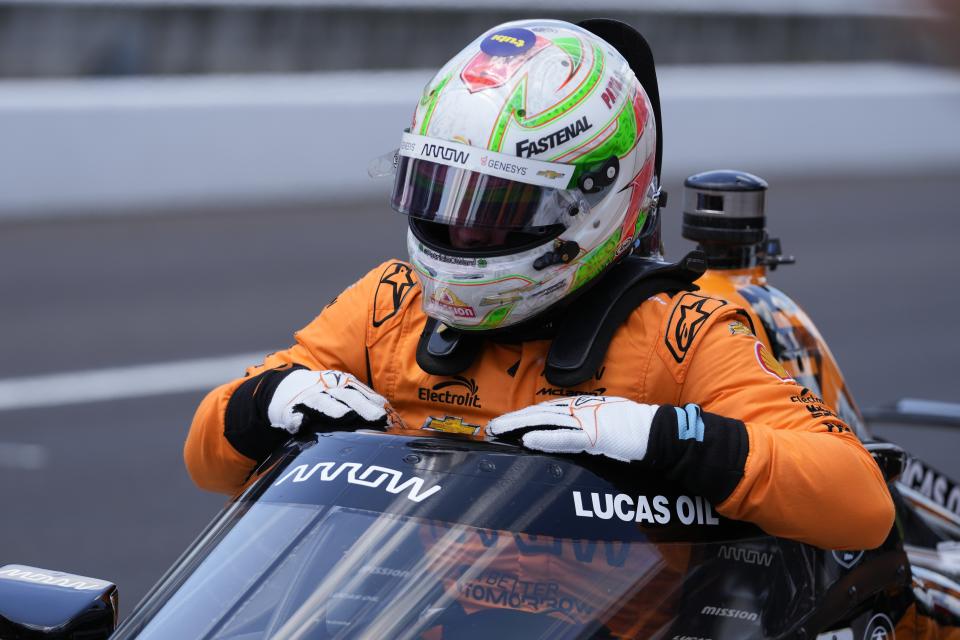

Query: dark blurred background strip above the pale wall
left=0, top=0, right=955, bottom=77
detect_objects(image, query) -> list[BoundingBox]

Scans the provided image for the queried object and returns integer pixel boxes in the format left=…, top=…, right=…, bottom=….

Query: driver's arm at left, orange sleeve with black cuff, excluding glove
left=183, top=265, right=383, bottom=493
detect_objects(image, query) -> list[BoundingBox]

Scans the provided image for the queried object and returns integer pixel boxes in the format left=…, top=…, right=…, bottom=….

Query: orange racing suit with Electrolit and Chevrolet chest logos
left=184, top=261, right=893, bottom=549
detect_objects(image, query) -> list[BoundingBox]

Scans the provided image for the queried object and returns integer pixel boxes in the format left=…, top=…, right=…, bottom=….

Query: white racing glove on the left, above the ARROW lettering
left=267, top=369, right=394, bottom=433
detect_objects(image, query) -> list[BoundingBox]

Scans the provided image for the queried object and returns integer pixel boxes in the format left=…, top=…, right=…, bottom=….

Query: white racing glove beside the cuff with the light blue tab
left=487, top=396, right=659, bottom=462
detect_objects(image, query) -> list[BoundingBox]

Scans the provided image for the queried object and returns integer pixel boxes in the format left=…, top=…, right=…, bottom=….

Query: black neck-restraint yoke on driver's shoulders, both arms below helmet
left=417, top=251, right=706, bottom=387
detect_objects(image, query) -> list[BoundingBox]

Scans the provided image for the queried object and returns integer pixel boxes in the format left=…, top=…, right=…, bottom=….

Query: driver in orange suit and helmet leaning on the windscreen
left=185, top=20, right=893, bottom=549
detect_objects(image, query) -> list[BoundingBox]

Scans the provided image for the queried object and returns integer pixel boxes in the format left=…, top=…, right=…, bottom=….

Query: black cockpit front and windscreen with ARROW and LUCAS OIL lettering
left=97, top=432, right=922, bottom=639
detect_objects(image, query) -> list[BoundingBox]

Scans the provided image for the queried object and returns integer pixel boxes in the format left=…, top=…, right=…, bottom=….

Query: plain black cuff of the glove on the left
left=223, top=365, right=306, bottom=463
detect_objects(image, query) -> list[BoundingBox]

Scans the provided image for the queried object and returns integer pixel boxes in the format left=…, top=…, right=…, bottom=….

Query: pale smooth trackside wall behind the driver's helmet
left=0, top=65, right=960, bottom=218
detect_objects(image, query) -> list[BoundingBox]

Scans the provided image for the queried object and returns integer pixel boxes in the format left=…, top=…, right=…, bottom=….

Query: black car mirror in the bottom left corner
left=0, top=564, right=119, bottom=640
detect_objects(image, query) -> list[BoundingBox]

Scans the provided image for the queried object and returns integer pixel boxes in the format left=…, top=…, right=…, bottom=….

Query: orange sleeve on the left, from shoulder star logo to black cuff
left=183, top=262, right=410, bottom=493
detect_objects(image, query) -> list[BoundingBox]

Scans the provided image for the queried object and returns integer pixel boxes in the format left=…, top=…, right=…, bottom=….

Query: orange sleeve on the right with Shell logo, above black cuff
left=680, top=309, right=894, bottom=549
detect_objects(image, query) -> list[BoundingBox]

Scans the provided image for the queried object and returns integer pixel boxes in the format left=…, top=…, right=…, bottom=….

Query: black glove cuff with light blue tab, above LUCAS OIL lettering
left=644, top=405, right=750, bottom=505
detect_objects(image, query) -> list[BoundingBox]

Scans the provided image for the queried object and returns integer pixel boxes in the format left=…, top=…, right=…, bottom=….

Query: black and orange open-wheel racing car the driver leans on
left=0, top=166, right=960, bottom=640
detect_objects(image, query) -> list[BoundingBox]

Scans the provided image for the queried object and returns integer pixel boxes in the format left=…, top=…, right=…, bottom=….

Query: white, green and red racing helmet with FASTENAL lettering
left=391, top=20, right=659, bottom=331
